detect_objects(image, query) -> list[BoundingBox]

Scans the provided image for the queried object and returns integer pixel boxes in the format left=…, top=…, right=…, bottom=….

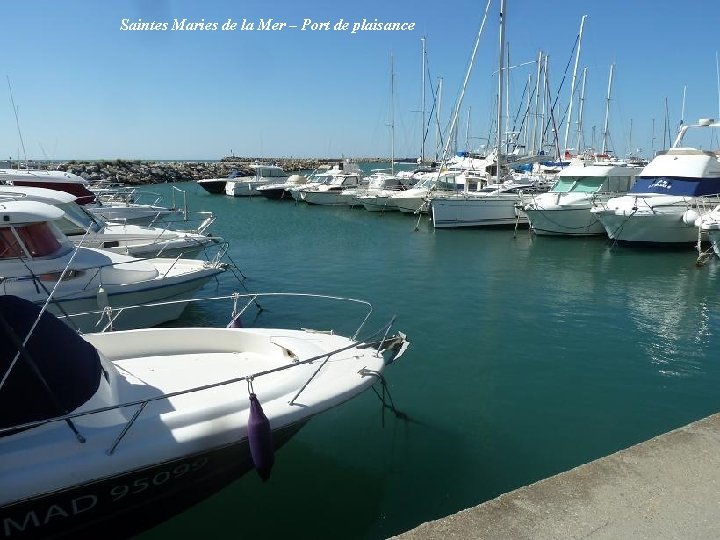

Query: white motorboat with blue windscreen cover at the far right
left=591, top=119, right=720, bottom=245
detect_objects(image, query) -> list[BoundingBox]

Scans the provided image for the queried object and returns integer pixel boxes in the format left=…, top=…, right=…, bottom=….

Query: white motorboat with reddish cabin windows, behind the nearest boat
left=0, top=200, right=226, bottom=332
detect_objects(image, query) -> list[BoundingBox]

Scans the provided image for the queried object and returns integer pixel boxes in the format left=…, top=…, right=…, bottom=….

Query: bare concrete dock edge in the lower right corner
left=394, top=414, right=720, bottom=540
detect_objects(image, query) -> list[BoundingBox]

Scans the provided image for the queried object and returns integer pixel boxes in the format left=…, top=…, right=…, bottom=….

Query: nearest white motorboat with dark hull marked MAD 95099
left=0, top=296, right=408, bottom=538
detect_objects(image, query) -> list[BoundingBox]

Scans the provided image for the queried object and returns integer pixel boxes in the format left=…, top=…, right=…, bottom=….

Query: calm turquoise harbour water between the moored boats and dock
left=134, top=175, right=720, bottom=540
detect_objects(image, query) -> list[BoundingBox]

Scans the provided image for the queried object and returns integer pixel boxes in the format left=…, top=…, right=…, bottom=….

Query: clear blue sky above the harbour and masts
left=0, top=0, right=720, bottom=160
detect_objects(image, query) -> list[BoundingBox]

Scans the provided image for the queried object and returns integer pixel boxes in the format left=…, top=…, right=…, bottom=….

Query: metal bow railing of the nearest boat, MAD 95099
left=0, top=293, right=408, bottom=455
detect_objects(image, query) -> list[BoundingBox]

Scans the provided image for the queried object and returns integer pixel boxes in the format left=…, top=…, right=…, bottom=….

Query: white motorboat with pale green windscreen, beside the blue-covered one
left=520, top=160, right=641, bottom=236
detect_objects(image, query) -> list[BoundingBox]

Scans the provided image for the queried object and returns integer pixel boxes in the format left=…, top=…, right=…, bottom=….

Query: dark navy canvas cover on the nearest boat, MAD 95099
left=0, top=295, right=103, bottom=428
